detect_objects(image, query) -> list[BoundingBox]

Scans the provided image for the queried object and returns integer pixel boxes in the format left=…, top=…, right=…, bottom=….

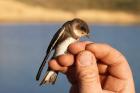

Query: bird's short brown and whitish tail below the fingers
left=40, top=69, right=58, bottom=85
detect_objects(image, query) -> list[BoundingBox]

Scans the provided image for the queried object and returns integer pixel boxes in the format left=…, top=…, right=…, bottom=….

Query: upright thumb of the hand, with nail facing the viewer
left=76, top=51, right=102, bottom=93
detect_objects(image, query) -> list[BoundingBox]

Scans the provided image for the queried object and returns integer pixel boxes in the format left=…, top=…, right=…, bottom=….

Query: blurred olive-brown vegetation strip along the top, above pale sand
left=17, top=0, right=140, bottom=13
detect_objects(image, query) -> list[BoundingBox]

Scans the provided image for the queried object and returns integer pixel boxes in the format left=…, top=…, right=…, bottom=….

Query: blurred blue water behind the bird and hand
left=0, top=23, right=140, bottom=93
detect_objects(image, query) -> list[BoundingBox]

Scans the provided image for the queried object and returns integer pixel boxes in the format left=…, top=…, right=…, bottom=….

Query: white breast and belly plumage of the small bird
left=54, top=37, right=77, bottom=57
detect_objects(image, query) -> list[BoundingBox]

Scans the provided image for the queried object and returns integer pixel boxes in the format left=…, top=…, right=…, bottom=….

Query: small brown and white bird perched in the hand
left=36, top=18, right=89, bottom=85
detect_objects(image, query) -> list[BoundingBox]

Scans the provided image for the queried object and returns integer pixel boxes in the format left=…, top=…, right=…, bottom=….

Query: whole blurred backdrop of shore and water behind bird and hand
left=0, top=0, right=140, bottom=93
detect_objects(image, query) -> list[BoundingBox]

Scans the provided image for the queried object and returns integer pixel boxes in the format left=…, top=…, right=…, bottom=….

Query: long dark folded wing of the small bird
left=36, top=27, right=65, bottom=80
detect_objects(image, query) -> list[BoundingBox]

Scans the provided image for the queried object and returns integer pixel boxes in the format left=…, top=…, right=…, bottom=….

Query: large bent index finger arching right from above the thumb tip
left=86, top=44, right=131, bottom=79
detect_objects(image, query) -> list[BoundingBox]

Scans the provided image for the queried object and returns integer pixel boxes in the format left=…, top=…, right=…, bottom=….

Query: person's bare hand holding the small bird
left=49, top=42, right=135, bottom=93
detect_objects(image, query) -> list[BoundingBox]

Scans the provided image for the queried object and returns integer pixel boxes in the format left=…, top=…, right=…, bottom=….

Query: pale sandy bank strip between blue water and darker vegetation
left=0, top=0, right=140, bottom=24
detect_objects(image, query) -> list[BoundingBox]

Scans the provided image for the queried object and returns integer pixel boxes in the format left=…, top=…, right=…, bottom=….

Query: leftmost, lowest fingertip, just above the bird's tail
left=48, top=59, right=68, bottom=73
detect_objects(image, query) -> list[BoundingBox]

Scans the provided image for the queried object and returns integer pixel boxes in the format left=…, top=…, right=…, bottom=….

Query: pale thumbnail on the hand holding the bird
left=79, top=51, right=93, bottom=66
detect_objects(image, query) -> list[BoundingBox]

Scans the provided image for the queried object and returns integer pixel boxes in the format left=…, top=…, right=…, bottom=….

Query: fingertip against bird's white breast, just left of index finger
left=68, top=41, right=91, bottom=55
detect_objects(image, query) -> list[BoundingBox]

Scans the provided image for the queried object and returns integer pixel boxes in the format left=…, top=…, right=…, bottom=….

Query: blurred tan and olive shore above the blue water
left=0, top=0, right=140, bottom=24
